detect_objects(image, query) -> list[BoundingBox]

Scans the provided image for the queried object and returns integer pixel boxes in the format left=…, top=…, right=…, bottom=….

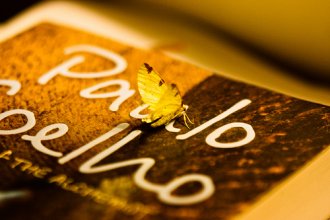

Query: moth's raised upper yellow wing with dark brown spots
left=138, top=63, right=168, bottom=111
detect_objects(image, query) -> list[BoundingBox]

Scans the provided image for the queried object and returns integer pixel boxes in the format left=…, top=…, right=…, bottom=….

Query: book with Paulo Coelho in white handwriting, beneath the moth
left=0, top=3, right=330, bottom=219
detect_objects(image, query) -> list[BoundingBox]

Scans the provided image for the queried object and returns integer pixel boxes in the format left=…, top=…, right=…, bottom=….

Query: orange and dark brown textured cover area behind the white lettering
left=0, top=23, right=330, bottom=219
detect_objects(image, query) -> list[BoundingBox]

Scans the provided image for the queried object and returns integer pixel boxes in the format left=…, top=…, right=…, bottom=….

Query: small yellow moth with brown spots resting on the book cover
left=137, top=63, right=193, bottom=128
